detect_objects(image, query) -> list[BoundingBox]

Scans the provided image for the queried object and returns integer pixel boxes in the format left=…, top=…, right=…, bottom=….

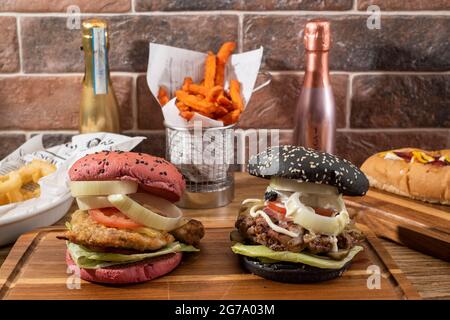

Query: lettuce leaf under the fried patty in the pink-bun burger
left=67, top=241, right=200, bottom=269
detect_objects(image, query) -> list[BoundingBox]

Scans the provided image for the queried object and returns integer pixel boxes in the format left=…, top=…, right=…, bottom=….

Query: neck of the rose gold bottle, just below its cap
left=303, top=51, right=330, bottom=88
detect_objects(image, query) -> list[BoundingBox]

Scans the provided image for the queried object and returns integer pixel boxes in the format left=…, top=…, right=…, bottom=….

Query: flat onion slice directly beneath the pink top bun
left=69, top=180, right=138, bottom=197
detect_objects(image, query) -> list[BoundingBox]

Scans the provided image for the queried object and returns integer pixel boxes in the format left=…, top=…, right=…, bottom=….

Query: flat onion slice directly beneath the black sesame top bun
left=270, top=177, right=339, bottom=195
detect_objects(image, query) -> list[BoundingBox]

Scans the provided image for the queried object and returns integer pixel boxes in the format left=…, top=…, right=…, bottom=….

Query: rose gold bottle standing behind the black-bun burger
left=294, top=20, right=336, bottom=153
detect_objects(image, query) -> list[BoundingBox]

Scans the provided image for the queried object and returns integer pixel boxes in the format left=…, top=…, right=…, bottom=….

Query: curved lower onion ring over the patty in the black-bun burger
left=286, top=192, right=350, bottom=236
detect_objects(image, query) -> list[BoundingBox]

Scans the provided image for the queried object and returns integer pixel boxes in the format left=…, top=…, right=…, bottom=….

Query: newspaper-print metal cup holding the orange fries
left=165, top=123, right=234, bottom=209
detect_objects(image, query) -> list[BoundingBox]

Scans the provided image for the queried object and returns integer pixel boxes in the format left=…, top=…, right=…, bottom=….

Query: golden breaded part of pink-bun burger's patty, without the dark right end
left=65, top=210, right=175, bottom=252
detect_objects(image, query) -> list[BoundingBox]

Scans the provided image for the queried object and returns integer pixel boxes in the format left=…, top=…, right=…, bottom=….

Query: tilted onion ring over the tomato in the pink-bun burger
left=108, top=193, right=187, bottom=231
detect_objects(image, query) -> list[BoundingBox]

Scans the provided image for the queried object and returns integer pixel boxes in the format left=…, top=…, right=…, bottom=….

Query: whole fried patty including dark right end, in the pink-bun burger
left=61, top=210, right=205, bottom=252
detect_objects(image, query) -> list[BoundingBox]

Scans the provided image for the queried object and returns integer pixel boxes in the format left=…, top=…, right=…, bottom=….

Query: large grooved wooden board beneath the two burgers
left=0, top=174, right=420, bottom=299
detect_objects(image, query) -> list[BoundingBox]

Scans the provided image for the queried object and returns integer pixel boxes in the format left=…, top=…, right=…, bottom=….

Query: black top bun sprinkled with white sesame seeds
left=248, top=145, right=369, bottom=196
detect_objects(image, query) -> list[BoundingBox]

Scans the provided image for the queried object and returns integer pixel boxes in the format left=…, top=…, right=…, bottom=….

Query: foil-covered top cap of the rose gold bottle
left=303, top=19, right=330, bottom=51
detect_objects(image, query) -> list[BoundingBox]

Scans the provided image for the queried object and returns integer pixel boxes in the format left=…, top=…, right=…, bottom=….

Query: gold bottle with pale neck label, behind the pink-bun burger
left=80, top=19, right=120, bottom=133
